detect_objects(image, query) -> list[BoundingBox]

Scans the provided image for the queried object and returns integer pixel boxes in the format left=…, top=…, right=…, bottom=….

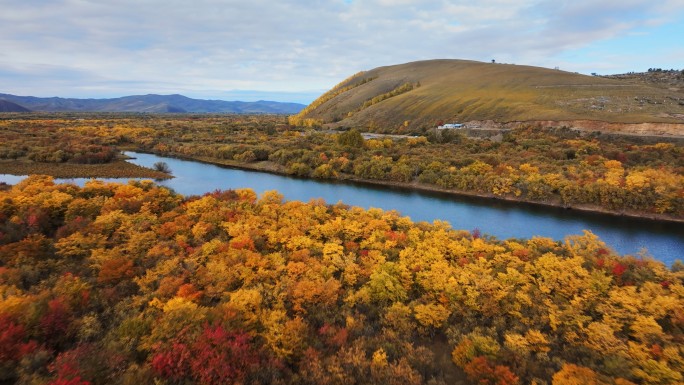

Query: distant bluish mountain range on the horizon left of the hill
left=0, top=93, right=305, bottom=114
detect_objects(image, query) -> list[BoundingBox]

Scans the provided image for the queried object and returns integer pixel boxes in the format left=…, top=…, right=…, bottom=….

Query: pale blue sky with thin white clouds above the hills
left=0, top=0, right=684, bottom=104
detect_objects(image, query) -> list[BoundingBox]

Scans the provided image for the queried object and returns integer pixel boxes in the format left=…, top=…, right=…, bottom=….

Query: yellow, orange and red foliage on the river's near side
left=0, top=176, right=684, bottom=385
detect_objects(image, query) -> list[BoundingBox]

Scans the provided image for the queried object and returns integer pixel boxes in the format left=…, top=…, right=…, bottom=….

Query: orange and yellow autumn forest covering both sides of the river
left=0, top=115, right=684, bottom=385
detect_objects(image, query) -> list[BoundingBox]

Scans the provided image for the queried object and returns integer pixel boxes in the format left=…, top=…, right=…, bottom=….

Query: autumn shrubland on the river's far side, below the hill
left=0, top=115, right=684, bottom=218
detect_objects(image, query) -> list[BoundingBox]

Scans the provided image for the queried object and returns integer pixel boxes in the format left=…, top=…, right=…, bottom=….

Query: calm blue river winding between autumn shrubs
left=0, top=152, right=684, bottom=265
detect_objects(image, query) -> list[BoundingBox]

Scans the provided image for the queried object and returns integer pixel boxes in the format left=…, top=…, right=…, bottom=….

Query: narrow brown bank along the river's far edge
left=128, top=148, right=684, bottom=224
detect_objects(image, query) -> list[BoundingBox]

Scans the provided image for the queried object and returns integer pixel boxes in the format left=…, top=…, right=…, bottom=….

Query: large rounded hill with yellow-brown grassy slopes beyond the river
left=295, top=60, right=684, bottom=135
